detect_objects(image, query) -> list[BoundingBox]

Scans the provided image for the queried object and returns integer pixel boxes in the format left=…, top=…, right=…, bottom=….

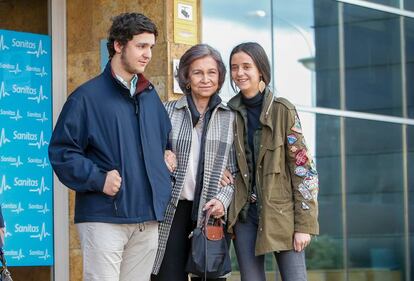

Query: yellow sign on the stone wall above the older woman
left=174, top=0, right=198, bottom=45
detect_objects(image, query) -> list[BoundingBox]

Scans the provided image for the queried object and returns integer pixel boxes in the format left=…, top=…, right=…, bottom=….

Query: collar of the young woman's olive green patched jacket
left=227, top=87, right=274, bottom=131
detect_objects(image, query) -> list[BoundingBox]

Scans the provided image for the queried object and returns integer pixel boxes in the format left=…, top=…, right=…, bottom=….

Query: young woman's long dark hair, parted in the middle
left=229, top=42, right=271, bottom=92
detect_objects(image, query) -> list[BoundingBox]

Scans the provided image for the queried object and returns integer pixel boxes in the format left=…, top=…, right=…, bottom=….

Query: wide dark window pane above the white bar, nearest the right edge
left=344, top=5, right=402, bottom=116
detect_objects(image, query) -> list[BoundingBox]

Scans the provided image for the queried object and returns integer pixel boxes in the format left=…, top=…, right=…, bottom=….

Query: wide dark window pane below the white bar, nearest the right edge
left=345, top=119, right=405, bottom=280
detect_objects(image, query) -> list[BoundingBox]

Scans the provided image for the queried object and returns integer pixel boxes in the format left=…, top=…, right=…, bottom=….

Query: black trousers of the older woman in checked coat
left=151, top=200, right=226, bottom=281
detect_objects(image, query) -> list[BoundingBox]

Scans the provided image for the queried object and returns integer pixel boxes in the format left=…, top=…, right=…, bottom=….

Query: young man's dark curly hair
left=106, top=13, right=158, bottom=58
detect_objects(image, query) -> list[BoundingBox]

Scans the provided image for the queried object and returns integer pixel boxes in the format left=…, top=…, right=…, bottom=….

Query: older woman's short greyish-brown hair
left=177, top=44, right=226, bottom=94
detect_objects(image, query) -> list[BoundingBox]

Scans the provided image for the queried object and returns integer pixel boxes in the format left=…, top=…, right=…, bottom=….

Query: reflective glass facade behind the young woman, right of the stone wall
left=202, top=0, right=414, bottom=280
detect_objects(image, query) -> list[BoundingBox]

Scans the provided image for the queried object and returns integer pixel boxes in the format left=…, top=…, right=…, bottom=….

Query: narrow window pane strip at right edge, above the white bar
left=405, top=17, right=414, bottom=118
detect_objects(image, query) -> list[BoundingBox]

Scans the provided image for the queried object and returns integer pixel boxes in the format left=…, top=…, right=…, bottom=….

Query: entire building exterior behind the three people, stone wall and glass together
left=0, top=0, right=414, bottom=281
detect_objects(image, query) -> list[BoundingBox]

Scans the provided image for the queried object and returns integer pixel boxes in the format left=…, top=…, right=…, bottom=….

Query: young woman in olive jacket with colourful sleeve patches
left=223, top=42, right=319, bottom=281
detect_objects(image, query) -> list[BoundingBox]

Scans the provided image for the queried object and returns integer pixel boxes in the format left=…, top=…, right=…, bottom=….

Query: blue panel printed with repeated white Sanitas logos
left=0, top=30, right=54, bottom=266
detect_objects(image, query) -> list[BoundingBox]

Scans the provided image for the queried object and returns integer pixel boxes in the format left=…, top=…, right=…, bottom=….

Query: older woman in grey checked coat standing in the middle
left=152, top=44, right=236, bottom=281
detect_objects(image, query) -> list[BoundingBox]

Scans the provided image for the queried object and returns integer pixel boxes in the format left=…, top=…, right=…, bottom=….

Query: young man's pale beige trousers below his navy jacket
left=77, top=222, right=158, bottom=281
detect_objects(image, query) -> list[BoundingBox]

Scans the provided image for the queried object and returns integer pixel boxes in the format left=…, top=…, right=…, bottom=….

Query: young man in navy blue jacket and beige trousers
left=49, top=13, right=171, bottom=281
